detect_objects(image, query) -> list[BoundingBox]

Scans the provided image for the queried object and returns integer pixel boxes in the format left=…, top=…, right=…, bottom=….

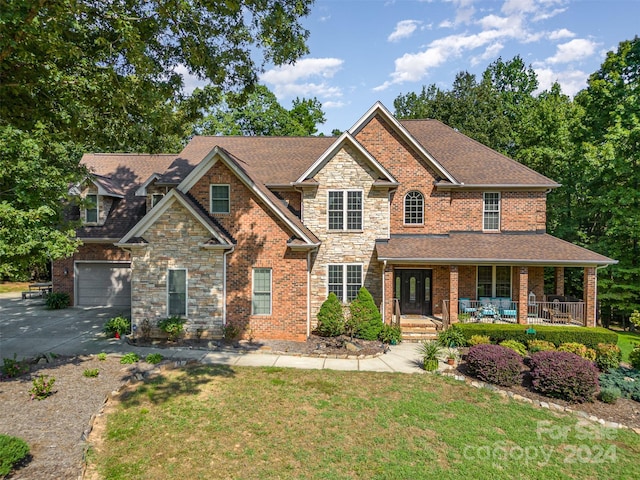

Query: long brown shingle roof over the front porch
left=376, top=233, right=617, bottom=266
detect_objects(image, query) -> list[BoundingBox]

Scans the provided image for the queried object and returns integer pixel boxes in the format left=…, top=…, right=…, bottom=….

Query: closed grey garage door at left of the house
left=76, top=263, right=131, bottom=307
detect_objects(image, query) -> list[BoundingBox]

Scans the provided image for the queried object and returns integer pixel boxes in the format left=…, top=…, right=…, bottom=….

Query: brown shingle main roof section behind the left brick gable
left=158, top=136, right=336, bottom=185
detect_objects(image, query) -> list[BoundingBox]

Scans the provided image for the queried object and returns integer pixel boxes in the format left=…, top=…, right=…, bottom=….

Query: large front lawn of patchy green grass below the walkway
left=91, top=366, right=640, bottom=480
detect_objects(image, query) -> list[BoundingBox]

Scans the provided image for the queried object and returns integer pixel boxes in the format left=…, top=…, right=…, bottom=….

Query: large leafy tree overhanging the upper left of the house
left=0, top=0, right=312, bottom=275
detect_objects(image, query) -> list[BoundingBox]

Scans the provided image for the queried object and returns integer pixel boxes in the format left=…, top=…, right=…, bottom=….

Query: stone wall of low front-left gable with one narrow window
left=131, top=201, right=223, bottom=337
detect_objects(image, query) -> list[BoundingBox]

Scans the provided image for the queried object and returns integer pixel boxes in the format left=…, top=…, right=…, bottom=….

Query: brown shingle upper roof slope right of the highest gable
left=400, top=120, right=559, bottom=188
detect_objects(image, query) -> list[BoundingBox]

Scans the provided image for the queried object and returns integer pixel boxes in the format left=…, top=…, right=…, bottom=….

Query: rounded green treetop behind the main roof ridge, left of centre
left=195, top=85, right=325, bottom=136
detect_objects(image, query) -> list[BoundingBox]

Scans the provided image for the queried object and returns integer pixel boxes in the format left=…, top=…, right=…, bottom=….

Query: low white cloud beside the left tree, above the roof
left=261, top=58, right=344, bottom=100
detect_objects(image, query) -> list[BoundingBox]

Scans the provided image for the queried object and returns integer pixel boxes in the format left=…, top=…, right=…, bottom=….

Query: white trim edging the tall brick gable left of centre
left=176, top=146, right=316, bottom=245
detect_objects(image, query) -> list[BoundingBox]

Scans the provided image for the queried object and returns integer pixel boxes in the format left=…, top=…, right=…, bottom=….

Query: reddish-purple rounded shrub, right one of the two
left=529, top=352, right=599, bottom=403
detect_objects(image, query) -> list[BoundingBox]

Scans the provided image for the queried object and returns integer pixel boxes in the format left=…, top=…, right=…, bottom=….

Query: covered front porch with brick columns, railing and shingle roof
left=376, top=233, right=615, bottom=328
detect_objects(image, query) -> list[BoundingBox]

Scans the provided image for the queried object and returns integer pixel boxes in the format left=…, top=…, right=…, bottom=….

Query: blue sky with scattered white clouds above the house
left=182, top=0, right=640, bottom=134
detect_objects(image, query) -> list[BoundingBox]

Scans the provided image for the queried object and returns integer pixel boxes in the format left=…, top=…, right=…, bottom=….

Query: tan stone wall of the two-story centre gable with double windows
left=303, top=146, right=389, bottom=326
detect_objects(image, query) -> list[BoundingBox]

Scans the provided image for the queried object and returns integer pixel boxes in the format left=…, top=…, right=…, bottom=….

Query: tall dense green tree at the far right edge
left=576, top=37, right=640, bottom=315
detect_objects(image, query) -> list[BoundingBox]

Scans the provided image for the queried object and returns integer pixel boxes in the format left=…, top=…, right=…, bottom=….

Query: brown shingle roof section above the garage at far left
left=76, top=153, right=176, bottom=239
